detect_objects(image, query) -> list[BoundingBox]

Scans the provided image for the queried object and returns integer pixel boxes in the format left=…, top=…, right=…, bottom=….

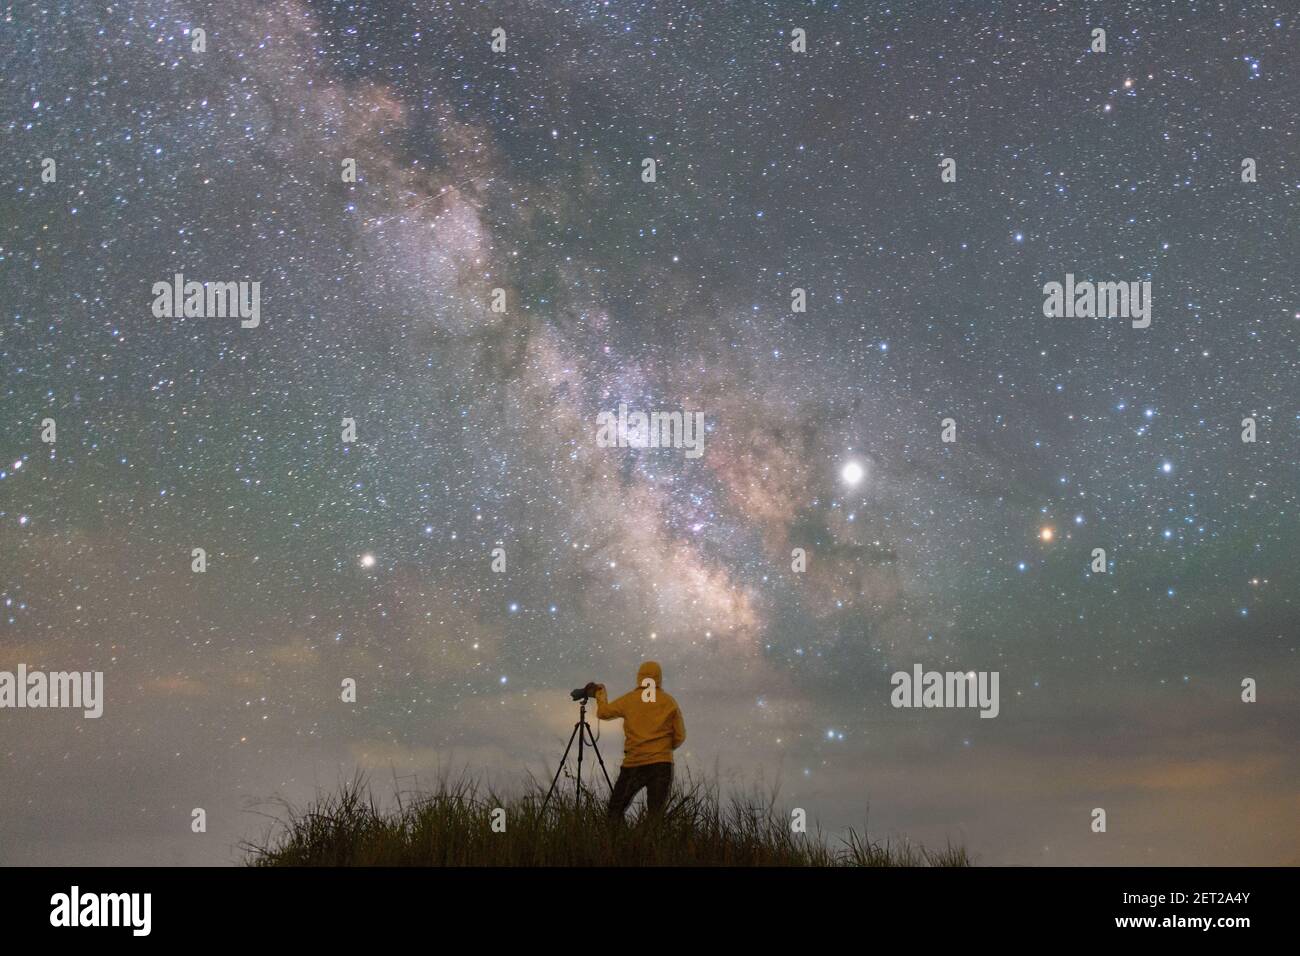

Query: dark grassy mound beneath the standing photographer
left=242, top=777, right=971, bottom=866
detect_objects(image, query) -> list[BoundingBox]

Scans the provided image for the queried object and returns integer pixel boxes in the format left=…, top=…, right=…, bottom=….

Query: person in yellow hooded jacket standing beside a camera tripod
left=588, top=661, right=686, bottom=819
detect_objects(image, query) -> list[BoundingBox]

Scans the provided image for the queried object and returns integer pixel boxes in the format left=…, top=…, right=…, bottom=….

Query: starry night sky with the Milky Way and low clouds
left=0, top=0, right=1300, bottom=865
